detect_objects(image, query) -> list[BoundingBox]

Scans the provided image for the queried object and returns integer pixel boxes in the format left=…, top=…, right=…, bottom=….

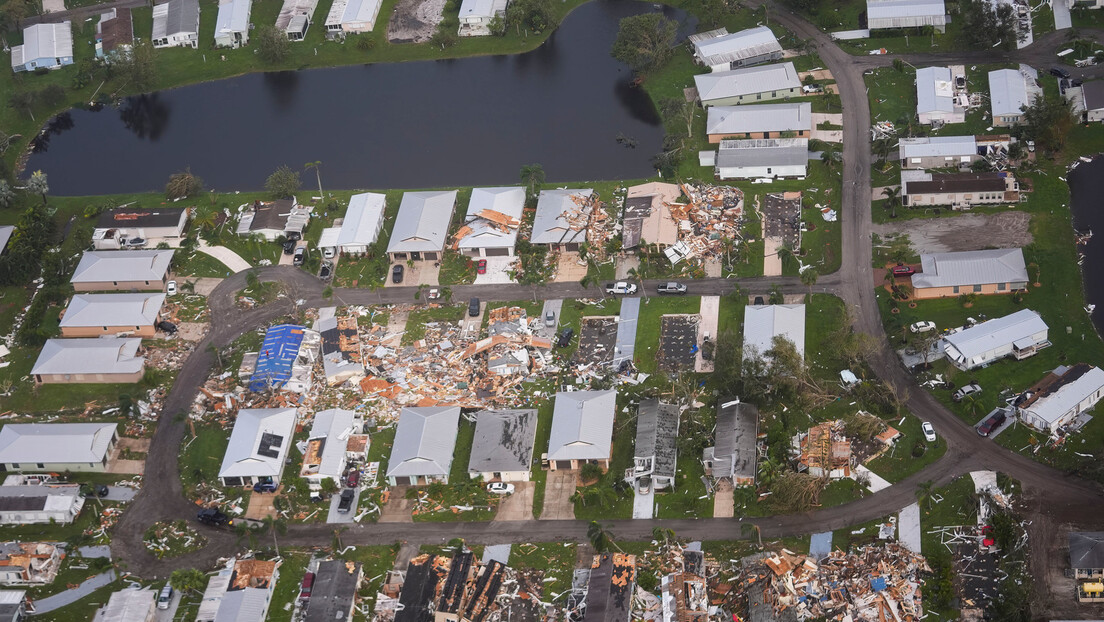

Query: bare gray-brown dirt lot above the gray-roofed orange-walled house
left=874, top=211, right=1034, bottom=253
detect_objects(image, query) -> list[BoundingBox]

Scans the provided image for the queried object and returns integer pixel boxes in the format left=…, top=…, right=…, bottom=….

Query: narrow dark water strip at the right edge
left=1066, top=157, right=1104, bottom=335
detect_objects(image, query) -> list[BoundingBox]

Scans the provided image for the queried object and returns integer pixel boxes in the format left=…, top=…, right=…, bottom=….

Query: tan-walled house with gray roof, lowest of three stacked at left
left=31, top=338, right=146, bottom=384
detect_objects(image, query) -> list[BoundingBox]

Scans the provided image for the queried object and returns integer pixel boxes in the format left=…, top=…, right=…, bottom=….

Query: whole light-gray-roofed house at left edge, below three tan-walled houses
left=0, top=423, right=119, bottom=473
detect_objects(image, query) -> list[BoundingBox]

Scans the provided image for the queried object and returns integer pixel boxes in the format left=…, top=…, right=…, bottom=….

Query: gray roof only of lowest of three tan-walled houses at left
left=31, top=337, right=146, bottom=376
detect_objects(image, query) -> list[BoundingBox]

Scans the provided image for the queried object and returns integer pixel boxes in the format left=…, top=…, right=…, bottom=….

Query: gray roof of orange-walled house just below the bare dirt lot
left=912, top=249, right=1028, bottom=288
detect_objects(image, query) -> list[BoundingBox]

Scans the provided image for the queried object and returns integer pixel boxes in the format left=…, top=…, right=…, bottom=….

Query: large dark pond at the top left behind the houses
left=26, top=0, right=694, bottom=194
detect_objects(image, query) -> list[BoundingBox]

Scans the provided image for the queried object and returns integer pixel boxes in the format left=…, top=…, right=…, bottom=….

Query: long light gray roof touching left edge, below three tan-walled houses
left=0, top=423, right=118, bottom=464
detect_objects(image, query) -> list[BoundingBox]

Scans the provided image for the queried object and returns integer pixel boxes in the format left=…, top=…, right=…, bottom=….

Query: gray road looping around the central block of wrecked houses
left=105, top=4, right=1104, bottom=596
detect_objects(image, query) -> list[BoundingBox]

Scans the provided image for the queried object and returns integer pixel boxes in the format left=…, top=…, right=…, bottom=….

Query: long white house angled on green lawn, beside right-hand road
left=943, top=309, right=1050, bottom=371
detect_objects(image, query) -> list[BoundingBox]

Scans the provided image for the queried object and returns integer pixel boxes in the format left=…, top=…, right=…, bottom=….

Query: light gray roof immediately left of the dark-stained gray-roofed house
left=388, top=407, right=460, bottom=477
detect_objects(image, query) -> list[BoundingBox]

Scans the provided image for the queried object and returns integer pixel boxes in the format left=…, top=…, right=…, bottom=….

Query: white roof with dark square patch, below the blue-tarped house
left=219, top=408, right=296, bottom=479
